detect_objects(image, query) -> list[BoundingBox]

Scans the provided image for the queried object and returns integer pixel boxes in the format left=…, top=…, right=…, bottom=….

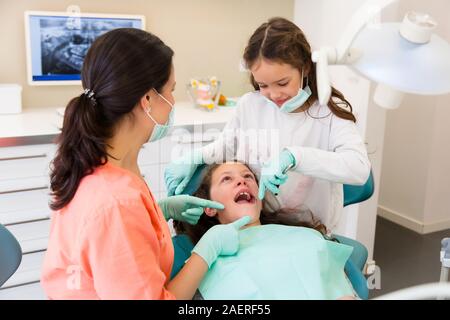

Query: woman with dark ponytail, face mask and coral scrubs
left=41, top=28, right=249, bottom=299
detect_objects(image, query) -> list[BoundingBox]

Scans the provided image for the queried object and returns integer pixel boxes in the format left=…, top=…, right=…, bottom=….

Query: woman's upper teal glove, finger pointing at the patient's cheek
left=158, top=195, right=224, bottom=224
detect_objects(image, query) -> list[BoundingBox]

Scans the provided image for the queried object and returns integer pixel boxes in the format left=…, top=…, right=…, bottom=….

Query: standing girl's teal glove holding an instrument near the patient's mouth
left=258, top=149, right=295, bottom=200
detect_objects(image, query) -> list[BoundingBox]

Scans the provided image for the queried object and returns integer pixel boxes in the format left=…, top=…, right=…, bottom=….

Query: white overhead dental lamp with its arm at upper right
left=312, top=0, right=450, bottom=109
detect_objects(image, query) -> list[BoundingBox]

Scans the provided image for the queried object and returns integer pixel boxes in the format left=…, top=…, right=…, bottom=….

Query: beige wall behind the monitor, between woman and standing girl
left=0, top=0, right=294, bottom=108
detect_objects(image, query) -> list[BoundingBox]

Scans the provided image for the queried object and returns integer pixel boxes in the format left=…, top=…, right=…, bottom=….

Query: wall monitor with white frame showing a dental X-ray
left=25, top=12, right=145, bottom=85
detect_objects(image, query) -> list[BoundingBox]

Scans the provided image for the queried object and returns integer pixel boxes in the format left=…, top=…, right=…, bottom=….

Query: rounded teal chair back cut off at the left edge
left=0, top=224, right=22, bottom=287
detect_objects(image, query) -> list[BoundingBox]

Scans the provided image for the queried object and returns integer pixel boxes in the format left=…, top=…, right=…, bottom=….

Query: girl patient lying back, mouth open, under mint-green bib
left=174, top=162, right=355, bottom=299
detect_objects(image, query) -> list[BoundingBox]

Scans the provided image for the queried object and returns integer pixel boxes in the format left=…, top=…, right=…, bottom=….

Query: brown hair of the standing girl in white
left=244, top=18, right=356, bottom=122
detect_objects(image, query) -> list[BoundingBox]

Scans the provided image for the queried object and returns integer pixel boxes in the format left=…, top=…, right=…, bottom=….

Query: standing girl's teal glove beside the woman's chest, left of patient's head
left=164, top=149, right=203, bottom=196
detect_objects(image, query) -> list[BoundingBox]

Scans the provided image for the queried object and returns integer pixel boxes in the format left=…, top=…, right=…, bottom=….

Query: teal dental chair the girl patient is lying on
left=171, top=165, right=374, bottom=300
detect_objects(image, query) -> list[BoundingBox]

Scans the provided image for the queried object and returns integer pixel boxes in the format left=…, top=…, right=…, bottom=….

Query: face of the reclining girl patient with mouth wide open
left=210, top=162, right=262, bottom=226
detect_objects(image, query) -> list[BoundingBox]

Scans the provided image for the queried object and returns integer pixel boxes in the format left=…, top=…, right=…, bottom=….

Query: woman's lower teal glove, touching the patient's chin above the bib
left=192, top=216, right=250, bottom=267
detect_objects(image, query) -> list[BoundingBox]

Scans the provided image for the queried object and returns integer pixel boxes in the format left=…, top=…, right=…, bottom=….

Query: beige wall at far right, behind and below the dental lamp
left=379, top=0, right=450, bottom=233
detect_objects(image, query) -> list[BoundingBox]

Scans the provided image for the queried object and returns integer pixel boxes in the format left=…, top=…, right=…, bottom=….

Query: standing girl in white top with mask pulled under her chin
left=165, top=18, right=370, bottom=232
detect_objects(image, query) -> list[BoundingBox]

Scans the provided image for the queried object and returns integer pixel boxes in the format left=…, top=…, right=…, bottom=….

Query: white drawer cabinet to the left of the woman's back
left=0, top=144, right=55, bottom=299
